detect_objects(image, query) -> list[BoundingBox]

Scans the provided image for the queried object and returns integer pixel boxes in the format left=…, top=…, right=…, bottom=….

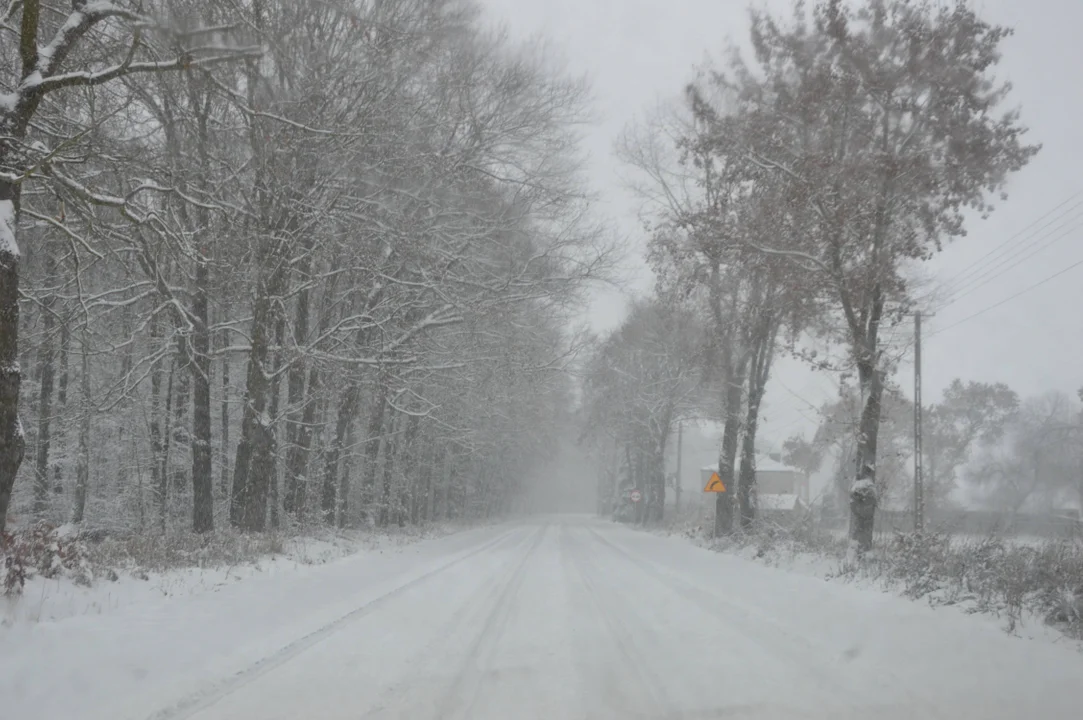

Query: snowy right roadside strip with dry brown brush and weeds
left=650, top=518, right=1083, bottom=651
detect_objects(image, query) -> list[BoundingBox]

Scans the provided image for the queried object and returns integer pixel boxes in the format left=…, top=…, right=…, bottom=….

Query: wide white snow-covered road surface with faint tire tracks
left=0, top=516, right=1083, bottom=720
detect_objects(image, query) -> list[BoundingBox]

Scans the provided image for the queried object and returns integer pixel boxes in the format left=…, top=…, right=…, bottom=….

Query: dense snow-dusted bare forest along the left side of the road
left=0, top=0, right=610, bottom=532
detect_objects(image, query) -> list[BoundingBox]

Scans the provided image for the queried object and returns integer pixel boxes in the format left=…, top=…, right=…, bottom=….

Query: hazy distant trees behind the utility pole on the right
left=782, top=380, right=1083, bottom=515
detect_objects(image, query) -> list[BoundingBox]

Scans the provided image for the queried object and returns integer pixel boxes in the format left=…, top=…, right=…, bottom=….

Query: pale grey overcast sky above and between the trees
left=482, top=0, right=1083, bottom=445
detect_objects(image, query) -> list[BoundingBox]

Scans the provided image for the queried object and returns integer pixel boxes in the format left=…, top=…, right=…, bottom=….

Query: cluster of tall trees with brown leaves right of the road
left=580, top=0, right=1038, bottom=549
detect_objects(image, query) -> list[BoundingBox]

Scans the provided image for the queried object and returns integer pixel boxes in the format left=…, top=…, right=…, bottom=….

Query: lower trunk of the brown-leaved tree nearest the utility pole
left=850, top=362, right=884, bottom=552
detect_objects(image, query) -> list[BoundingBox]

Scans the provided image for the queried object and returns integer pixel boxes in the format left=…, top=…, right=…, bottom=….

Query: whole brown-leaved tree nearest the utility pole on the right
left=693, top=0, right=1038, bottom=550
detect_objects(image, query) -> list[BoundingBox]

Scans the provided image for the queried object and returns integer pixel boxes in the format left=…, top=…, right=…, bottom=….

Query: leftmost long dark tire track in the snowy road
left=147, top=529, right=526, bottom=720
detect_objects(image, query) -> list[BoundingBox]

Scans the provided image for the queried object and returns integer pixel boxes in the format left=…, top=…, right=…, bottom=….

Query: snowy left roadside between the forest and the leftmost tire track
left=0, top=525, right=515, bottom=720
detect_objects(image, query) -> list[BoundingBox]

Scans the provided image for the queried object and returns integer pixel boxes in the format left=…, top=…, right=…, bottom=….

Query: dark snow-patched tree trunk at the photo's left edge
left=0, top=188, right=26, bottom=531
